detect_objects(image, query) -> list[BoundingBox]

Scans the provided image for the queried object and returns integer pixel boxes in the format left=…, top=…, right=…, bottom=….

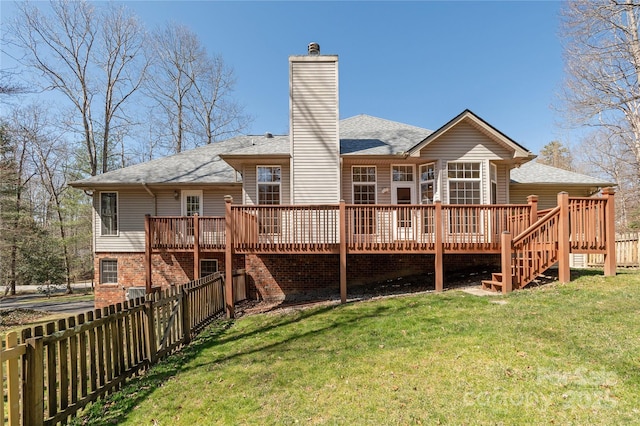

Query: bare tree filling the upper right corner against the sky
left=562, top=0, right=640, bottom=183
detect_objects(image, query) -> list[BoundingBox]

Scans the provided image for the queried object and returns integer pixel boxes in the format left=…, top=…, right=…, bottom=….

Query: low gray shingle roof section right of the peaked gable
left=511, top=161, right=615, bottom=187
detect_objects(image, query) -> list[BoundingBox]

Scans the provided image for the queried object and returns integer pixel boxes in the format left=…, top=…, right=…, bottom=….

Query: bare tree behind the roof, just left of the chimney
left=148, top=24, right=249, bottom=152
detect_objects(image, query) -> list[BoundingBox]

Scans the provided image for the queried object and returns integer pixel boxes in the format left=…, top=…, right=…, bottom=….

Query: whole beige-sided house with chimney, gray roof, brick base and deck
left=71, top=43, right=613, bottom=312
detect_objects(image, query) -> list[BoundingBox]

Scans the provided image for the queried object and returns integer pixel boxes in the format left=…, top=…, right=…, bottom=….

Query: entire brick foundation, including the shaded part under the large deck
left=94, top=252, right=500, bottom=308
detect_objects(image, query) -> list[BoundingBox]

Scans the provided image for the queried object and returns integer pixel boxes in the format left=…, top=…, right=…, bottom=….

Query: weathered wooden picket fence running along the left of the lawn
left=0, top=273, right=244, bottom=426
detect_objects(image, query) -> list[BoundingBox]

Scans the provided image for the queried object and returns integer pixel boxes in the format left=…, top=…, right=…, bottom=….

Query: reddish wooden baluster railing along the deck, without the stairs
left=149, top=204, right=531, bottom=253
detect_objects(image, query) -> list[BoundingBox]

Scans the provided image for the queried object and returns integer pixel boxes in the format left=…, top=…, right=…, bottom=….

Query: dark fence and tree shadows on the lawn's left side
left=70, top=305, right=398, bottom=425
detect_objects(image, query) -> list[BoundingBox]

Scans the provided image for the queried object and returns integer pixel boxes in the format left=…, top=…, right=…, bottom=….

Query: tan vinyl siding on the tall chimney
left=290, top=56, right=340, bottom=204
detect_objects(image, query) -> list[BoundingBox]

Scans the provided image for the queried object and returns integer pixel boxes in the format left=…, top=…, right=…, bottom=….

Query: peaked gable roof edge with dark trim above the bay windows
left=408, top=109, right=536, bottom=162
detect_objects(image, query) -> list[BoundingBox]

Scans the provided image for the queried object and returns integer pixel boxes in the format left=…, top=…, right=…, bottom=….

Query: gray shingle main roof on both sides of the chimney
left=71, top=115, right=431, bottom=188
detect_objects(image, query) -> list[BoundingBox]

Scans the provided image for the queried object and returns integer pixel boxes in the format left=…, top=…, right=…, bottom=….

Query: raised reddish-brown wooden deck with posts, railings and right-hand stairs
left=145, top=189, right=615, bottom=316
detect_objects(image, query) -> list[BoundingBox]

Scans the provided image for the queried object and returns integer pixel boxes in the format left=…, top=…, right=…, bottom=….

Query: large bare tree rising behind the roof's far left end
left=7, top=0, right=146, bottom=175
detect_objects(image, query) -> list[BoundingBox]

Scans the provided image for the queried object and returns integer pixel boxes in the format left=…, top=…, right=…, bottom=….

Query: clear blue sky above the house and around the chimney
left=2, top=1, right=575, bottom=153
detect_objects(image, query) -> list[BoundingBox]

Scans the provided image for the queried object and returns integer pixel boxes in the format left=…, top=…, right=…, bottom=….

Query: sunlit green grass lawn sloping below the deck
left=76, top=272, right=640, bottom=425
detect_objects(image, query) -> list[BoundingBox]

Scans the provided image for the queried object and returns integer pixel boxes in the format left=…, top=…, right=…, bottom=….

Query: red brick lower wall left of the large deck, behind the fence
left=94, top=252, right=244, bottom=309
